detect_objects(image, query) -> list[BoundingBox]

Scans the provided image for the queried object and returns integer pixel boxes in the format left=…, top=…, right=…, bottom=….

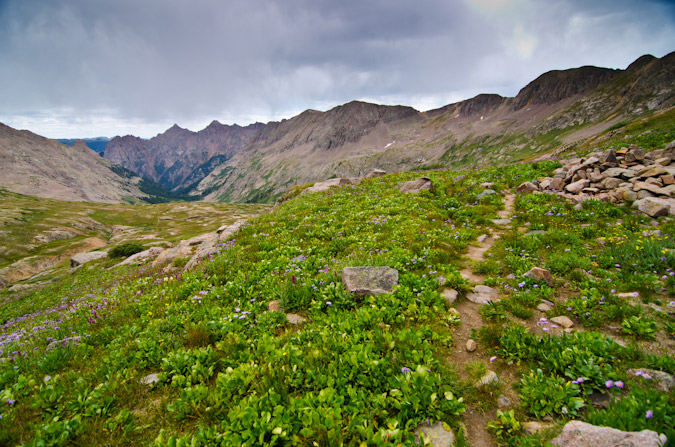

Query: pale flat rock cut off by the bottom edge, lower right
left=551, top=421, right=667, bottom=447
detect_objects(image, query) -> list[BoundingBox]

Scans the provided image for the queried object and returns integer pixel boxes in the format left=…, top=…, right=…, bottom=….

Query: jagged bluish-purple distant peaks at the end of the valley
left=104, top=121, right=263, bottom=190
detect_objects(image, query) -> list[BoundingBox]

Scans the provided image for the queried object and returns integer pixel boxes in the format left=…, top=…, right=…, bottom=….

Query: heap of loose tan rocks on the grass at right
left=532, top=141, right=675, bottom=217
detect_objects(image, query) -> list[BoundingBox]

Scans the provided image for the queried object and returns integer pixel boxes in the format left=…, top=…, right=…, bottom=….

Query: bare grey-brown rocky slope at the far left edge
left=0, top=123, right=145, bottom=203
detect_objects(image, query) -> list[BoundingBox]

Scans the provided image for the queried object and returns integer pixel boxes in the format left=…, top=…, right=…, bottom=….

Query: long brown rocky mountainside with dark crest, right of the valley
left=197, top=53, right=675, bottom=202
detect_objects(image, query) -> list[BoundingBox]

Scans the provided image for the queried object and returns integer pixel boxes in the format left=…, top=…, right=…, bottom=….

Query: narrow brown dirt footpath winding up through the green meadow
left=451, top=193, right=515, bottom=447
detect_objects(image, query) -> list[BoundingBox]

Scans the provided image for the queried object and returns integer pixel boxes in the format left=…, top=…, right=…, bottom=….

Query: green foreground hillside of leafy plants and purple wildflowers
left=0, top=161, right=675, bottom=447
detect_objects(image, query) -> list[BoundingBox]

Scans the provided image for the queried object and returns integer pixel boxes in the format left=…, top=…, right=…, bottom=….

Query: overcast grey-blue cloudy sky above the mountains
left=0, top=0, right=675, bottom=138
